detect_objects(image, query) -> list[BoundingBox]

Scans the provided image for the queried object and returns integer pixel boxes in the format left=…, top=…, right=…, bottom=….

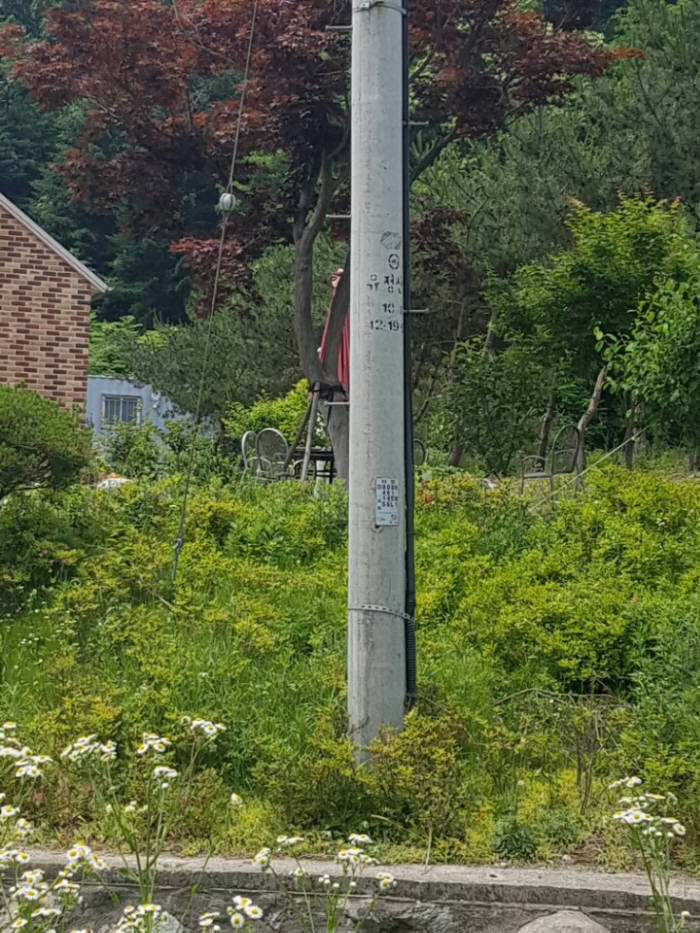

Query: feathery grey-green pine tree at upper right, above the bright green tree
left=414, top=0, right=700, bottom=288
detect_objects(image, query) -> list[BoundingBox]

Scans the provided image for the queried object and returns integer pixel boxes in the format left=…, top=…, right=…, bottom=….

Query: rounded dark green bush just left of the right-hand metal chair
left=446, top=338, right=547, bottom=474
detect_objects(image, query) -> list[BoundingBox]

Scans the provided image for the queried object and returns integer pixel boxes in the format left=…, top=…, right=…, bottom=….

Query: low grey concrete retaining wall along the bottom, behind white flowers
left=24, top=852, right=700, bottom=933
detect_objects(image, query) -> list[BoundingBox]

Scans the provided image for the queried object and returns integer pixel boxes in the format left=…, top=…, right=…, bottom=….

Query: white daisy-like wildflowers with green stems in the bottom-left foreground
left=0, top=717, right=396, bottom=933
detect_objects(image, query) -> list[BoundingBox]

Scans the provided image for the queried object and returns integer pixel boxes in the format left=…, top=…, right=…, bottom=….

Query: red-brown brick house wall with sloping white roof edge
left=0, top=194, right=107, bottom=406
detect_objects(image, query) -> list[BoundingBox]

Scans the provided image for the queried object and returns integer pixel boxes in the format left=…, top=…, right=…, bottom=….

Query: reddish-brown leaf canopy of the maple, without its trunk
left=8, top=0, right=608, bottom=251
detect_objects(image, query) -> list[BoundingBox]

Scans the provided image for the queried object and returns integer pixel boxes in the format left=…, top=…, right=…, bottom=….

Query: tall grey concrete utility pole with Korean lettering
left=348, top=0, right=406, bottom=756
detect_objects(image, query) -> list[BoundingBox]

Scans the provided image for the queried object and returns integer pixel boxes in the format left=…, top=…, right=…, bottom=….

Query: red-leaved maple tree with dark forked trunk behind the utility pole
left=1, top=0, right=624, bottom=472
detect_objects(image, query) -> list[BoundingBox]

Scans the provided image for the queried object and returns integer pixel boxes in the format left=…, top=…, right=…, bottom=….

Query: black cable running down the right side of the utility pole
left=402, top=0, right=417, bottom=709
